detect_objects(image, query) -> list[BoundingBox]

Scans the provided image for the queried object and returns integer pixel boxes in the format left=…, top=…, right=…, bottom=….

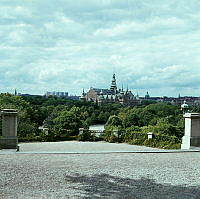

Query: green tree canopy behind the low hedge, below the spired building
left=0, top=94, right=185, bottom=141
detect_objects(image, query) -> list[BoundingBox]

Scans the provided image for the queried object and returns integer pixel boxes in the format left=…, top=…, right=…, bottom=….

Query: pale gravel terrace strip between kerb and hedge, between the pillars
left=19, top=141, right=162, bottom=153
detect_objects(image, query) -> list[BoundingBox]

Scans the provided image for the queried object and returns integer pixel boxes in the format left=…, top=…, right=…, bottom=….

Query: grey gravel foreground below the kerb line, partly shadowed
left=0, top=141, right=200, bottom=199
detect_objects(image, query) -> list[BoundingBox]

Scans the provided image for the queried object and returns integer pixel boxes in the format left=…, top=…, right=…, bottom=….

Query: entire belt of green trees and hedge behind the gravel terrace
left=0, top=94, right=189, bottom=147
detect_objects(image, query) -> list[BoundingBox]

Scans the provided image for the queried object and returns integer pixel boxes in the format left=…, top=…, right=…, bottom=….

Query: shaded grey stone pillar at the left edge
left=0, top=109, right=18, bottom=149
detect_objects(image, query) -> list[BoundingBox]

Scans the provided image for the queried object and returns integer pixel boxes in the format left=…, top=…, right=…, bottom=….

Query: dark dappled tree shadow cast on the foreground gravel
left=65, top=174, right=200, bottom=199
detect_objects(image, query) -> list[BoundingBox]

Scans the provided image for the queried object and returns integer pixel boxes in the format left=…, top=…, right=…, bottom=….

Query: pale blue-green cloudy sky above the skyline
left=0, top=0, right=200, bottom=97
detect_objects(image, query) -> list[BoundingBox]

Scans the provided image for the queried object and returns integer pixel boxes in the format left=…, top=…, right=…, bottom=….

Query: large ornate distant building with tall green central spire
left=80, top=74, right=141, bottom=106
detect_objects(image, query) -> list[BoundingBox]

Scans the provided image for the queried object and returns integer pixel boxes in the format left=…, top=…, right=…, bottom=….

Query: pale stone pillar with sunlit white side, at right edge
left=181, top=113, right=200, bottom=149
